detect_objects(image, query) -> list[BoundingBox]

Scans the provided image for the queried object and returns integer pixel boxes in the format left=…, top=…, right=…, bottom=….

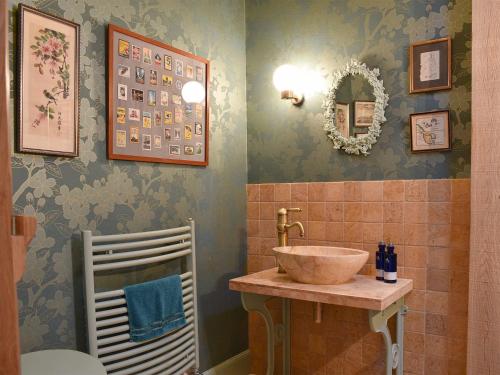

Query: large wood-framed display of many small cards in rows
left=107, top=25, right=210, bottom=166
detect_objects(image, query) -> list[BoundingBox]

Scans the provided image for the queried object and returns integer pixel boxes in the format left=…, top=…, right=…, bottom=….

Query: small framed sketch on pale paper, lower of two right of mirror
left=410, top=111, right=451, bottom=152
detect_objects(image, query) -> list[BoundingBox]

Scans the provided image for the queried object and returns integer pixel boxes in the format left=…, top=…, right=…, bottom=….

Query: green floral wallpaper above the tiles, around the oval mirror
left=246, top=0, right=471, bottom=183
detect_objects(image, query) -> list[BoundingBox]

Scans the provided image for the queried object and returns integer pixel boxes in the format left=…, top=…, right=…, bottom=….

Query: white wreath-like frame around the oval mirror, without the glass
left=323, top=59, right=389, bottom=156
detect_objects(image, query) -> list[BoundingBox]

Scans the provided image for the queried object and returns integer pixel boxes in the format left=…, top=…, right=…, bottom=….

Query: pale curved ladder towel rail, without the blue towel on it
left=82, top=219, right=199, bottom=375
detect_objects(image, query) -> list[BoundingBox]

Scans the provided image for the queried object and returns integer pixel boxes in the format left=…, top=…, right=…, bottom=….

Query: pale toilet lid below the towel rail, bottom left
left=21, top=350, right=106, bottom=375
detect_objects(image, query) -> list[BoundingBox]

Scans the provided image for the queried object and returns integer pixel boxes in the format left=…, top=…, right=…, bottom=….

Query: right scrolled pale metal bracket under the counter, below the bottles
left=368, top=297, right=408, bottom=375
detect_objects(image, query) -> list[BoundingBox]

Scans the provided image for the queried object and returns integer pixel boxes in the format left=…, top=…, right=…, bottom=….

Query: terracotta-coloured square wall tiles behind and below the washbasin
left=247, top=179, right=470, bottom=375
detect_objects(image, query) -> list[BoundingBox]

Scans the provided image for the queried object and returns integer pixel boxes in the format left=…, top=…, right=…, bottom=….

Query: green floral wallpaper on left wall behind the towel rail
left=9, top=0, right=247, bottom=369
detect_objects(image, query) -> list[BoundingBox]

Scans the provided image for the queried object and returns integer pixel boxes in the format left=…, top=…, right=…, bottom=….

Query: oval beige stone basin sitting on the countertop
left=273, top=246, right=368, bottom=285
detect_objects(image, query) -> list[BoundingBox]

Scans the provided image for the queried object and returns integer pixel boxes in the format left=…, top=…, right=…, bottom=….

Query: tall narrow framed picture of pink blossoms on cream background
left=16, top=4, right=80, bottom=157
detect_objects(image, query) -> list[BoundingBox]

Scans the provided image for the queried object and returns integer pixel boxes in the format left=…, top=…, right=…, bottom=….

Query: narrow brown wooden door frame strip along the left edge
left=0, top=1, right=20, bottom=375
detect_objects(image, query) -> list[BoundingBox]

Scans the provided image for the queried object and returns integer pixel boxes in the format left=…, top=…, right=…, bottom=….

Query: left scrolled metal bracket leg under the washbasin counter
left=241, top=292, right=276, bottom=375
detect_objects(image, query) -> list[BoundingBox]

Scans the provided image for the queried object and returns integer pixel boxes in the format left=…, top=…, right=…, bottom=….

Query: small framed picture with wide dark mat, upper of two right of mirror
left=408, top=37, right=451, bottom=94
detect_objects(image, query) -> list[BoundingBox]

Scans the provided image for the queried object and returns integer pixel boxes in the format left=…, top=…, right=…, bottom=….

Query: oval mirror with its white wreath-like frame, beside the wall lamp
left=324, top=60, right=389, bottom=155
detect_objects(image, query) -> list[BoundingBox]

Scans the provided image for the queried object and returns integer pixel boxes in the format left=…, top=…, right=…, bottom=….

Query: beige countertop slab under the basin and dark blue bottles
left=229, top=268, right=413, bottom=311
